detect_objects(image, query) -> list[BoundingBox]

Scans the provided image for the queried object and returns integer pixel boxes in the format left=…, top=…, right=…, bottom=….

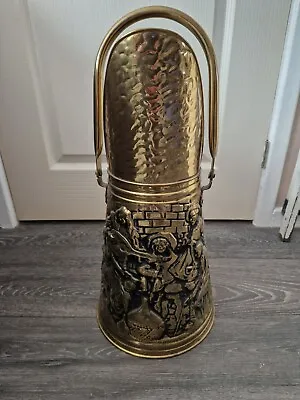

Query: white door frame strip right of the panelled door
left=253, top=0, right=300, bottom=227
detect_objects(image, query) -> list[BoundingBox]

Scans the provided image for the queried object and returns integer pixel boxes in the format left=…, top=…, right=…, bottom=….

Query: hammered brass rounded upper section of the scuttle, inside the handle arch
left=104, top=29, right=203, bottom=184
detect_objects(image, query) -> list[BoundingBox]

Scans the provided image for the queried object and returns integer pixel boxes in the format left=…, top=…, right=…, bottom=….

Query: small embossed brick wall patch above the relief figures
left=133, top=203, right=190, bottom=234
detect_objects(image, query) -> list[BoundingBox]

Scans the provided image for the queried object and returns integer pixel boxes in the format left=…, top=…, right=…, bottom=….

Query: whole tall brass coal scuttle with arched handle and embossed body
left=94, top=6, right=217, bottom=358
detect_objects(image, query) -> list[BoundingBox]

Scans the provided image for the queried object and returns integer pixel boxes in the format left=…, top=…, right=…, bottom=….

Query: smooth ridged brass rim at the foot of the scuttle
left=97, top=307, right=214, bottom=358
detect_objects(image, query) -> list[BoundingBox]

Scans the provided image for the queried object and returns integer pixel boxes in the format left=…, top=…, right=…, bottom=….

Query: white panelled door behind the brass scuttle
left=0, top=0, right=291, bottom=220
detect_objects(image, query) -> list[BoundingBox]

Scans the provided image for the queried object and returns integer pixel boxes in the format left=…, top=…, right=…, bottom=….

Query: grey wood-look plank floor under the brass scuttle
left=0, top=222, right=300, bottom=400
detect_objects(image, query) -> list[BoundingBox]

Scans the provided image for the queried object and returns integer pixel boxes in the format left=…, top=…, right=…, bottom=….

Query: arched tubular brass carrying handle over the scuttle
left=94, top=6, right=218, bottom=191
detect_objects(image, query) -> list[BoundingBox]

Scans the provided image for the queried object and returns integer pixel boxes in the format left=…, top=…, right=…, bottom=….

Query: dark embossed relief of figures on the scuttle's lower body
left=102, top=204, right=208, bottom=341
